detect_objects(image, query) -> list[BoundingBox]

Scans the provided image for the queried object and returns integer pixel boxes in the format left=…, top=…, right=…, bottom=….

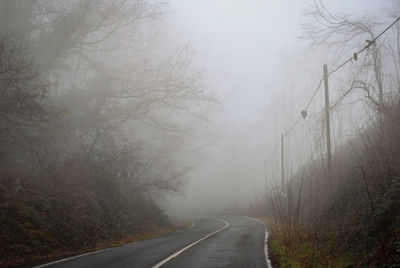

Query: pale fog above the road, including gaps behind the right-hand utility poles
left=164, top=1, right=390, bottom=212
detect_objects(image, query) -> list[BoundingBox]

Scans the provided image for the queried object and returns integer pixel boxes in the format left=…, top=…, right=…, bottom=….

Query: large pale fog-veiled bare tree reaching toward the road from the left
left=23, top=0, right=213, bottom=194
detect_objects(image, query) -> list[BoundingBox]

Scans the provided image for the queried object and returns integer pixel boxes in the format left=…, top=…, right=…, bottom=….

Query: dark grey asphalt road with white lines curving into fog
left=38, top=216, right=267, bottom=268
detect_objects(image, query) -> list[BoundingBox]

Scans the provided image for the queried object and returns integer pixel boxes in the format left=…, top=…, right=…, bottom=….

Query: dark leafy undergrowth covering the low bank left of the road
left=0, top=173, right=170, bottom=267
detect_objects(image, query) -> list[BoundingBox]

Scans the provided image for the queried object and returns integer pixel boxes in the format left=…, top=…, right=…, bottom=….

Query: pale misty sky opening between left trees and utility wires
left=164, top=0, right=390, bottom=214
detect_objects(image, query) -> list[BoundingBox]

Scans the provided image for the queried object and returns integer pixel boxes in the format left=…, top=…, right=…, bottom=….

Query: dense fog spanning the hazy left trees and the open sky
left=1, top=0, right=398, bottom=213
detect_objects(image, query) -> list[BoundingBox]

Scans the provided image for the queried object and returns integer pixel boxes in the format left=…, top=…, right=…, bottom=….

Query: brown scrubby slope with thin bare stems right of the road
left=268, top=95, right=400, bottom=267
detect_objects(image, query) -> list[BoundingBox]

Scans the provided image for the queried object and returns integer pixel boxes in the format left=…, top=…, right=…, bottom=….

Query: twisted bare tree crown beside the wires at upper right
left=302, top=1, right=398, bottom=112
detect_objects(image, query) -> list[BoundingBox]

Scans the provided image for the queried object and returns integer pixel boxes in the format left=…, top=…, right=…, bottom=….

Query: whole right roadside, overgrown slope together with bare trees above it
left=251, top=3, right=400, bottom=267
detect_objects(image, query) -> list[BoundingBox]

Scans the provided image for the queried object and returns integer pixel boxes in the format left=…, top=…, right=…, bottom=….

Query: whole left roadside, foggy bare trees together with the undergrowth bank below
left=0, top=0, right=212, bottom=265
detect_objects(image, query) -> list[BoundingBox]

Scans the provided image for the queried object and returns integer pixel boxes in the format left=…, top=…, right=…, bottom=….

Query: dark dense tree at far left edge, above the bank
left=0, top=33, right=56, bottom=168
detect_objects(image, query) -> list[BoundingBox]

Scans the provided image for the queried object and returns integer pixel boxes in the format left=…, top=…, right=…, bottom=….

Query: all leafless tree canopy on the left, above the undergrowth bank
left=0, top=0, right=213, bottom=193
